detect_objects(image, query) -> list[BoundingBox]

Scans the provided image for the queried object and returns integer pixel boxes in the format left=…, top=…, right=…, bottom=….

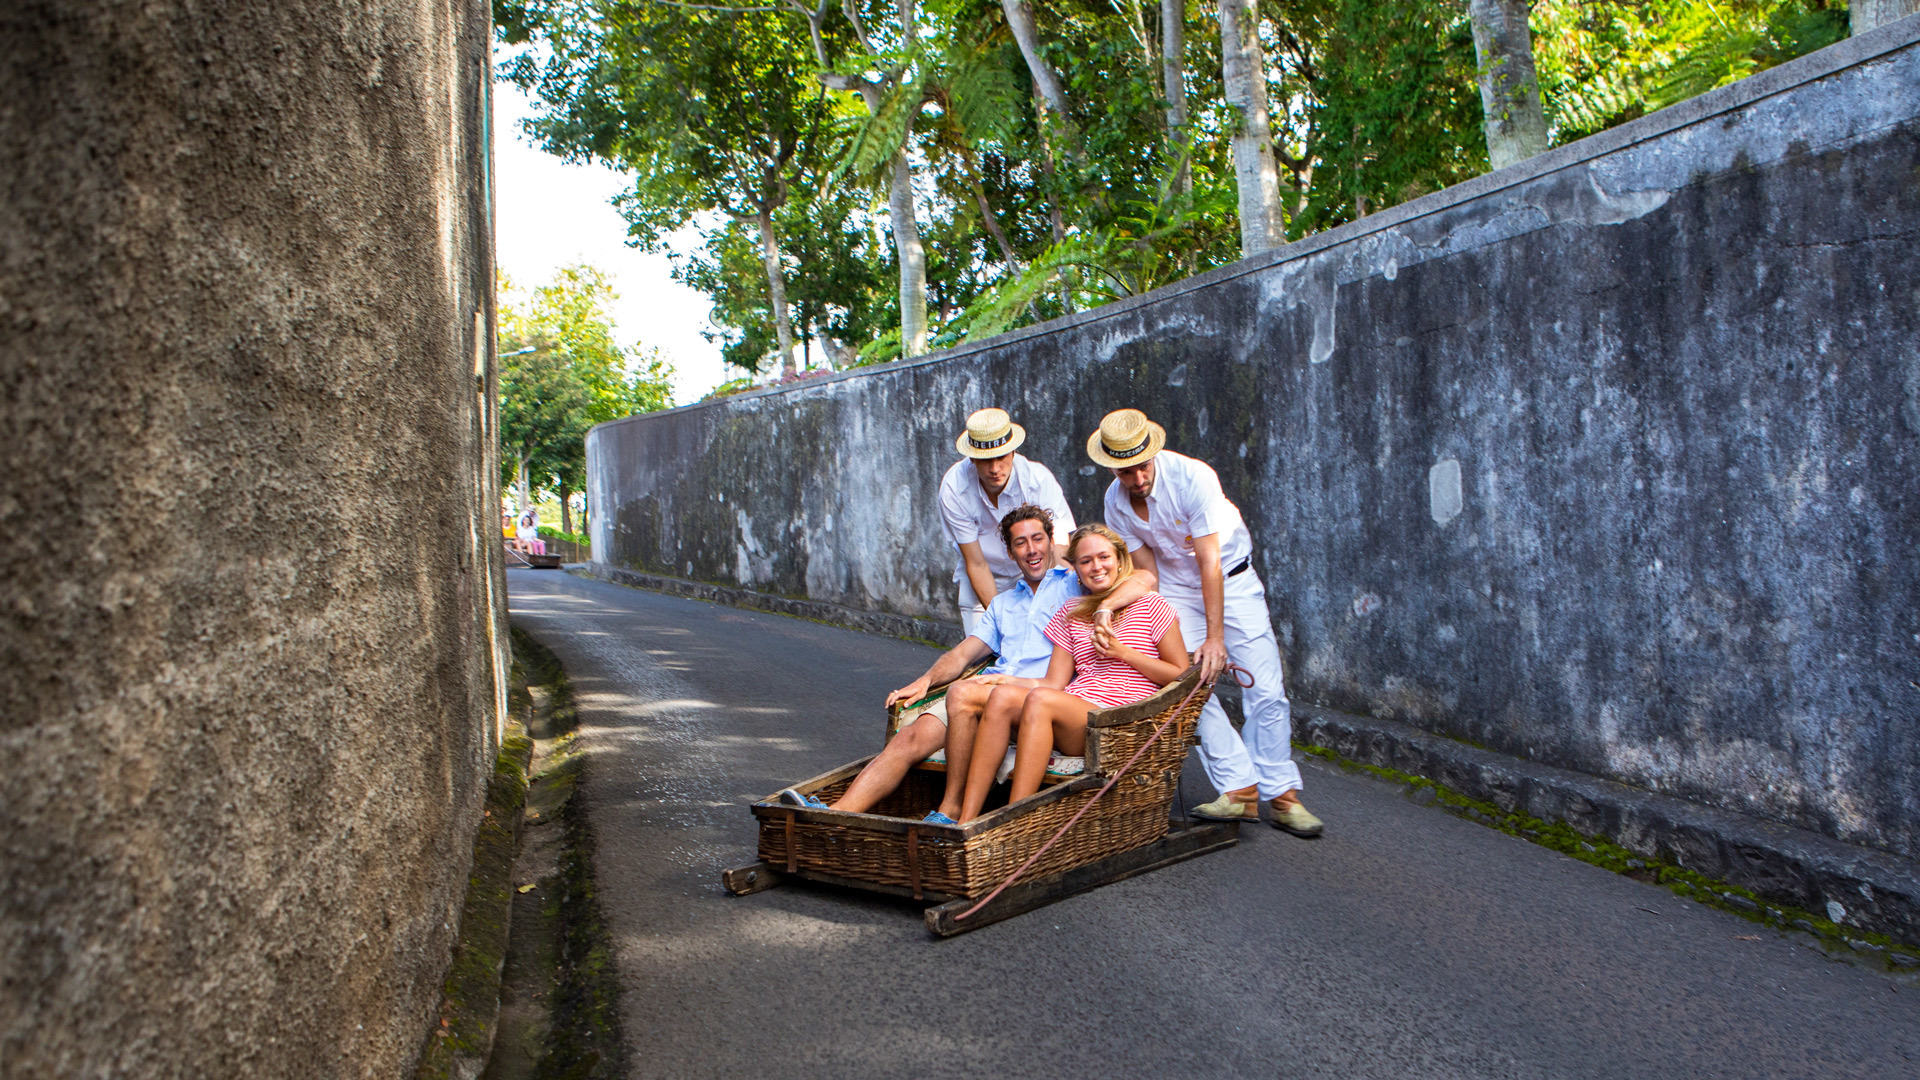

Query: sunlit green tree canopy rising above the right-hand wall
left=495, top=0, right=1847, bottom=384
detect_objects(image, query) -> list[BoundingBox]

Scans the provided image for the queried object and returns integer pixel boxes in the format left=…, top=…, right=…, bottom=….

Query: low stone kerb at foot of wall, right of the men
left=1294, top=701, right=1920, bottom=944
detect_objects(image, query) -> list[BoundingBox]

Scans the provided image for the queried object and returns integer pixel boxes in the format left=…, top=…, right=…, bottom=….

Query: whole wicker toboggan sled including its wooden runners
left=722, top=669, right=1238, bottom=938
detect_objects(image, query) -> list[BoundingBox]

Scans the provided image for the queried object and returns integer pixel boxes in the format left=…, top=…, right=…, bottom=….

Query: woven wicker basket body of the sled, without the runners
left=753, top=669, right=1212, bottom=899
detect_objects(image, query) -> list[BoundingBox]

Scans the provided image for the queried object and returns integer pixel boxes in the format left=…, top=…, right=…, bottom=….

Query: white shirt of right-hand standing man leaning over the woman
left=1106, top=450, right=1254, bottom=594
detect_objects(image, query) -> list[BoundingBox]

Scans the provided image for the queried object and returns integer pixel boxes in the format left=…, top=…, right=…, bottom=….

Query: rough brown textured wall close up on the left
left=0, top=0, right=505, bottom=1080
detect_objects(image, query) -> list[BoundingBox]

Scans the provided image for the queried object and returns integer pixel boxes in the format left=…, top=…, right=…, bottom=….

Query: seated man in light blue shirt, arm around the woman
left=780, top=503, right=1154, bottom=824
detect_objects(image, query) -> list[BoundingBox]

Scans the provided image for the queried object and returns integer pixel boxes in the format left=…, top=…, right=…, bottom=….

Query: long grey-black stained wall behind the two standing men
left=588, top=21, right=1920, bottom=855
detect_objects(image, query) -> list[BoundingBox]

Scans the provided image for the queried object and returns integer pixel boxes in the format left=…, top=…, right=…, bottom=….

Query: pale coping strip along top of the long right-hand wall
left=591, top=15, right=1920, bottom=430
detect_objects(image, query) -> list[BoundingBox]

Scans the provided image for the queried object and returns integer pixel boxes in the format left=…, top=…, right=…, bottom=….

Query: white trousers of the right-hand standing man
left=1164, top=567, right=1300, bottom=799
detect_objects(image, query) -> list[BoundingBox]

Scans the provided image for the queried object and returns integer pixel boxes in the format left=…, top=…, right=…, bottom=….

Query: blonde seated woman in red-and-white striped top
left=960, top=525, right=1187, bottom=822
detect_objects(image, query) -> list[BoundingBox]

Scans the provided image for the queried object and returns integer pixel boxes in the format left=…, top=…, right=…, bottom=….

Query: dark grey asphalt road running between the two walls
left=509, top=571, right=1920, bottom=1080
